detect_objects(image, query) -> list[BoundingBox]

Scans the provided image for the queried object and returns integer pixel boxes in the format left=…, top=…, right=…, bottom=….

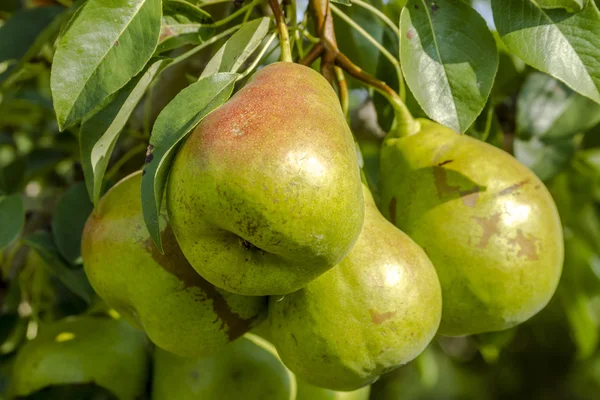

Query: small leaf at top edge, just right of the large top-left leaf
left=156, top=0, right=215, bottom=53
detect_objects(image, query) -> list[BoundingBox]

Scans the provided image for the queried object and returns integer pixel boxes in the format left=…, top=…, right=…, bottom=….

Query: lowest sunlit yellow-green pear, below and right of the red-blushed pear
left=268, top=187, right=442, bottom=391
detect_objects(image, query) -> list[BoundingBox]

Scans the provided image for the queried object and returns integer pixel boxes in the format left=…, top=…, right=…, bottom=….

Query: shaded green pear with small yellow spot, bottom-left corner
left=9, top=316, right=150, bottom=400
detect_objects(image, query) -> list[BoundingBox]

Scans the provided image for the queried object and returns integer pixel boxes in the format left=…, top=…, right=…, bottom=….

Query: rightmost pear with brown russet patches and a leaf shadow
left=381, top=120, right=563, bottom=336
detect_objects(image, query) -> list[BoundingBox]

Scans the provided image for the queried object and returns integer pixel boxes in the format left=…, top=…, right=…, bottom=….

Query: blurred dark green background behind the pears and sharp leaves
left=0, top=0, right=600, bottom=400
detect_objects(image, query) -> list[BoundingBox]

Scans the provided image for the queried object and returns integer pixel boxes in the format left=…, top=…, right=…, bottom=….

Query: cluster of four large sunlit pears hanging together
left=82, top=63, right=563, bottom=391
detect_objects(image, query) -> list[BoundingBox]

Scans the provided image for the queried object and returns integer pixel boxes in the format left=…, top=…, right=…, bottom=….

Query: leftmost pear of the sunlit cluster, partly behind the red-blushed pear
left=81, top=173, right=267, bottom=356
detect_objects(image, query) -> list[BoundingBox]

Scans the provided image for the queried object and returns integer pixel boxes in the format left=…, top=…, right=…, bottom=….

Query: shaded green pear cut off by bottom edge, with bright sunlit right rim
left=152, top=334, right=296, bottom=400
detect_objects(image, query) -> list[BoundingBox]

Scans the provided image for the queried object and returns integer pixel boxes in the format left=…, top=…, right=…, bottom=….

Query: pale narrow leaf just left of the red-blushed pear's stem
left=200, top=18, right=270, bottom=79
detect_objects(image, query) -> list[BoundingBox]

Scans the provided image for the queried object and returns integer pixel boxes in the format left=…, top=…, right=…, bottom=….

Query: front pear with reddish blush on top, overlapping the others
left=167, top=63, right=364, bottom=295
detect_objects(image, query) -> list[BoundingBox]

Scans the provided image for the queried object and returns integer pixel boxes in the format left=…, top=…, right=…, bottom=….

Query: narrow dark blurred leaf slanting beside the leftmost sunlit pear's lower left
left=25, top=232, right=94, bottom=304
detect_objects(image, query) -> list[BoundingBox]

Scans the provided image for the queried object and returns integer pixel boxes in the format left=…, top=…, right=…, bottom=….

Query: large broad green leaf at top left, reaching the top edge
left=51, top=0, right=162, bottom=130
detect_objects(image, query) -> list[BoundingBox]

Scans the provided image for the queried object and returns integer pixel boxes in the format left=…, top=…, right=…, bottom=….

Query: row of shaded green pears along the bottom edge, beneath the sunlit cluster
left=8, top=314, right=370, bottom=400
